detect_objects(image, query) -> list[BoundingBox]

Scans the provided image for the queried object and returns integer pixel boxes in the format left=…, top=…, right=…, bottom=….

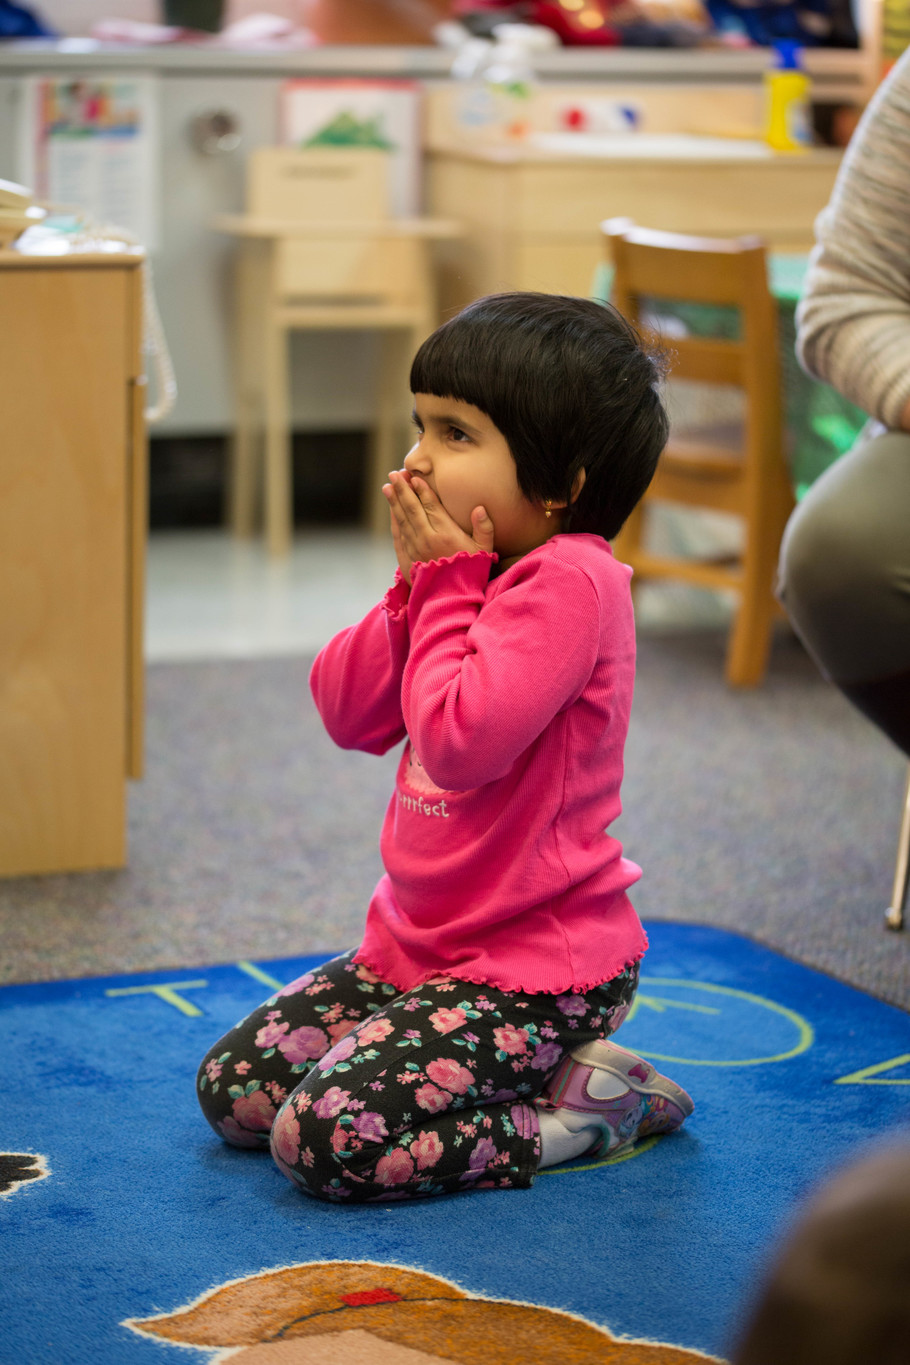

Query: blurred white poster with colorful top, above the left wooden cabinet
left=20, top=75, right=158, bottom=251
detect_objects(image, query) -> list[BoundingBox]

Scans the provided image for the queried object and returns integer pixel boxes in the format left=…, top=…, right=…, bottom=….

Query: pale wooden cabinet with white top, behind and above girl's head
left=427, top=142, right=840, bottom=315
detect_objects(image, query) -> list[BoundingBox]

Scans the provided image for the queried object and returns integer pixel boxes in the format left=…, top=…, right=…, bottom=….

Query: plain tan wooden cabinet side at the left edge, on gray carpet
left=0, top=244, right=146, bottom=876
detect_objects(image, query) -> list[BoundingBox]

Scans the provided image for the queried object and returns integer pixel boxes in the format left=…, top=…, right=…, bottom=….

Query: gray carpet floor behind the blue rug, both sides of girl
left=0, top=632, right=910, bottom=1009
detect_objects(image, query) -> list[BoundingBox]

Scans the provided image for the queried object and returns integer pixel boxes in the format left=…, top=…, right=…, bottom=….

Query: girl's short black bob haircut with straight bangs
left=411, top=293, right=669, bottom=541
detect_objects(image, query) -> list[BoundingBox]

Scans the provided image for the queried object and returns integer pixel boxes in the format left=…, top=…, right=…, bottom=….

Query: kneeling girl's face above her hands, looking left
left=404, top=393, right=561, bottom=566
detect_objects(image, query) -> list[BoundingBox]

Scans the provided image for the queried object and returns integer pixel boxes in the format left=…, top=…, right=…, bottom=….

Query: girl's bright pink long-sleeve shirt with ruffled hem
left=310, top=535, right=647, bottom=994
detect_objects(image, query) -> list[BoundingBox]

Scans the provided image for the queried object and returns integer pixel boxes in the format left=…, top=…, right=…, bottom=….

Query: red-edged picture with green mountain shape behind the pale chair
left=280, top=78, right=420, bottom=218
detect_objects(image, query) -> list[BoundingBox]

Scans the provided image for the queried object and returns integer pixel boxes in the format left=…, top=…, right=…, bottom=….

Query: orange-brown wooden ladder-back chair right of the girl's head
left=600, top=218, right=793, bottom=687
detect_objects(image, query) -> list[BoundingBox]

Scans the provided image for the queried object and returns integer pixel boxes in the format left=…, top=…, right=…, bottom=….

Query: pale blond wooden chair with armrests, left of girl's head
left=216, top=147, right=458, bottom=556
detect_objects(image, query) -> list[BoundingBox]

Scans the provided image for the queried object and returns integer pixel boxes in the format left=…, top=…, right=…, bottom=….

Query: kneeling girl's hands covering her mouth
left=382, top=470, right=494, bottom=584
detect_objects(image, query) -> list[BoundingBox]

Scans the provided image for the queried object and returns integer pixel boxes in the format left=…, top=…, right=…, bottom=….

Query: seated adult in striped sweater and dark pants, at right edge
left=779, top=51, right=910, bottom=755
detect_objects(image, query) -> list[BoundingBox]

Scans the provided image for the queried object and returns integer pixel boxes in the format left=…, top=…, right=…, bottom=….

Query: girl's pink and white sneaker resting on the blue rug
left=538, top=1039, right=694, bottom=1156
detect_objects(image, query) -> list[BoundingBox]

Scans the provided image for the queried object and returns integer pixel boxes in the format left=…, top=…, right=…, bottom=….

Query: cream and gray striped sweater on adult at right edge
left=797, top=51, right=910, bottom=427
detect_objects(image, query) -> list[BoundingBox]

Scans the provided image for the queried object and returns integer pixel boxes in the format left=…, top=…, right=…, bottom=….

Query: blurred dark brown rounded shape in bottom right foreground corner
left=733, top=1141, right=910, bottom=1365
